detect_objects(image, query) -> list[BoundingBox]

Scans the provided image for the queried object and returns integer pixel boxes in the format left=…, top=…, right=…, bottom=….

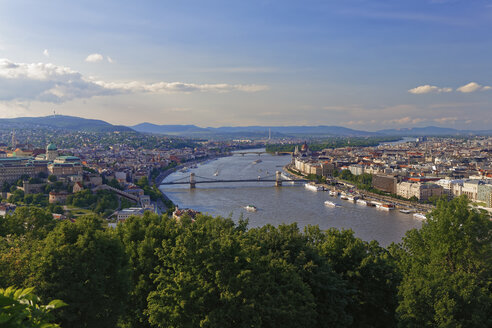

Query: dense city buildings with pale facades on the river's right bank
left=292, top=137, right=492, bottom=207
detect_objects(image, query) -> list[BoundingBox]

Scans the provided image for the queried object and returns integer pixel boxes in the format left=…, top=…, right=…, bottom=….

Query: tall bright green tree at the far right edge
left=397, top=197, right=492, bottom=328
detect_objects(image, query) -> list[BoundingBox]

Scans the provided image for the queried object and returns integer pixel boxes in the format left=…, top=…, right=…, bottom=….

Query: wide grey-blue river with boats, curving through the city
left=160, top=150, right=422, bottom=246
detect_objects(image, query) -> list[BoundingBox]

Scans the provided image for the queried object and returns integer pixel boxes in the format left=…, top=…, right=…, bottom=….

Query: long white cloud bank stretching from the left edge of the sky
left=0, top=59, right=268, bottom=103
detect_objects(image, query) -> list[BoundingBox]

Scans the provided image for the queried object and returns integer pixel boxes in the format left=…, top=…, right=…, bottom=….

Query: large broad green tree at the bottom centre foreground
left=148, top=217, right=343, bottom=327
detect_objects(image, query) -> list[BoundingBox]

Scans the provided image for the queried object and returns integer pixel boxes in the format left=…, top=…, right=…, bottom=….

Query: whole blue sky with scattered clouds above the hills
left=0, top=0, right=492, bottom=130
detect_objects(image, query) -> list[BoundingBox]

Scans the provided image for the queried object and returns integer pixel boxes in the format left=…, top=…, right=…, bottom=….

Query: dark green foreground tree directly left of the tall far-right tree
left=312, top=227, right=400, bottom=327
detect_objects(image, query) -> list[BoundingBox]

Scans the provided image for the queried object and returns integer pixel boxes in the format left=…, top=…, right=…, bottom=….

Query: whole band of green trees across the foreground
left=0, top=197, right=492, bottom=328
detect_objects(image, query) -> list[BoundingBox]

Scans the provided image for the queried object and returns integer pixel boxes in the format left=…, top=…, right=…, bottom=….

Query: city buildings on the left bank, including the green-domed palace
left=0, top=131, right=266, bottom=221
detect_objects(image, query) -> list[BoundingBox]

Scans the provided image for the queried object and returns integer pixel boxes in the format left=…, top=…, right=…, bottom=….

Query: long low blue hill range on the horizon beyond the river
left=131, top=123, right=378, bottom=137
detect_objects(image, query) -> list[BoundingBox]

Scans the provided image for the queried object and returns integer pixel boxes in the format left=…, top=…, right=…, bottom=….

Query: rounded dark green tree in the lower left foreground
left=34, top=216, right=130, bottom=328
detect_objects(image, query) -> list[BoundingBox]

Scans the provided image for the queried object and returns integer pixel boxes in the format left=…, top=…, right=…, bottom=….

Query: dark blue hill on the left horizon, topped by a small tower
left=0, top=115, right=132, bottom=132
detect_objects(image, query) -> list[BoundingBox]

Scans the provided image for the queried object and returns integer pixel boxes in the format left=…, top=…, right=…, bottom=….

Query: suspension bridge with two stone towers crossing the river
left=161, top=171, right=307, bottom=189
